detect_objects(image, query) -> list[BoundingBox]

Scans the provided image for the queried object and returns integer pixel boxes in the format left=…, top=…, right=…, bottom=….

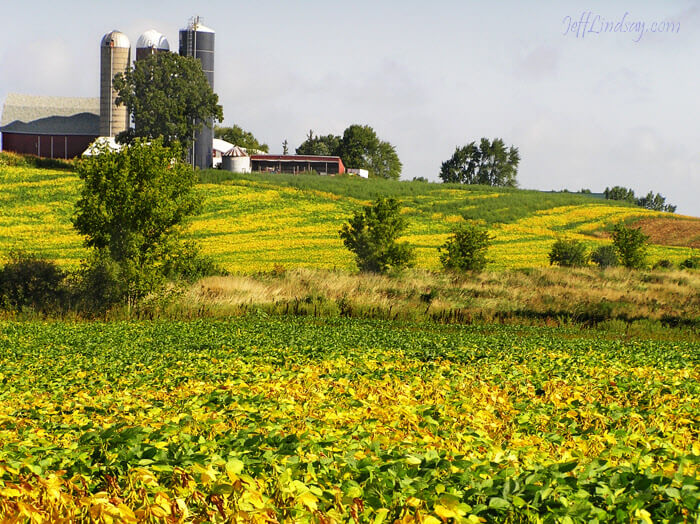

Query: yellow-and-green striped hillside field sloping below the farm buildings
left=0, top=162, right=700, bottom=273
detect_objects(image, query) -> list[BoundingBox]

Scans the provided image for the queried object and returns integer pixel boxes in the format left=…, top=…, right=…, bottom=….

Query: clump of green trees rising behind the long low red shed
left=296, top=124, right=403, bottom=180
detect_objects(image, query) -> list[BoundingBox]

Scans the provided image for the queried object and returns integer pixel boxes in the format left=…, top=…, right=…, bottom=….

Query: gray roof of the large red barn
left=0, top=93, right=100, bottom=136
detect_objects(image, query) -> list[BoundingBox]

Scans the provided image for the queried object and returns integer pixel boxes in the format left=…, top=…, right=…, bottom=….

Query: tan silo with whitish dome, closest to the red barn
left=100, top=31, right=131, bottom=136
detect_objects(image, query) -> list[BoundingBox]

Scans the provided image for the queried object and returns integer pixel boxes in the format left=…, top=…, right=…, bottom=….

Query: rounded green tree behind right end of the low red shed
left=337, top=124, right=403, bottom=180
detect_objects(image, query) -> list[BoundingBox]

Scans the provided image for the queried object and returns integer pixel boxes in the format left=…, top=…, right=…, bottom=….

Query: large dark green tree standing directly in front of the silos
left=114, top=53, right=224, bottom=151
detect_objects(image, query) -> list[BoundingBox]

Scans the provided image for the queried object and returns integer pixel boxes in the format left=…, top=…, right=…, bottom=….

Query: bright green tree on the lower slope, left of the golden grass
left=73, top=138, right=199, bottom=305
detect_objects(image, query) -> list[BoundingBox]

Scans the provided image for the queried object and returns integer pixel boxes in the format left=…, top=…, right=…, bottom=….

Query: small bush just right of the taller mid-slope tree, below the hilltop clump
left=438, top=224, right=493, bottom=271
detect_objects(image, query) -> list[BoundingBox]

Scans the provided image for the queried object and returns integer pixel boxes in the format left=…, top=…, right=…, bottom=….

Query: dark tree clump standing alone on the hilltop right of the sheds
left=440, top=138, right=520, bottom=187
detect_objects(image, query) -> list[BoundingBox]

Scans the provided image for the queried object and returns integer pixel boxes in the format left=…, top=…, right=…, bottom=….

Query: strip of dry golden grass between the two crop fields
left=180, top=268, right=700, bottom=321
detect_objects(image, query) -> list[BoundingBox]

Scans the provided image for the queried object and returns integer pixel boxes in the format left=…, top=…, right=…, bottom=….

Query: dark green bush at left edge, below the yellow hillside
left=0, top=252, right=68, bottom=313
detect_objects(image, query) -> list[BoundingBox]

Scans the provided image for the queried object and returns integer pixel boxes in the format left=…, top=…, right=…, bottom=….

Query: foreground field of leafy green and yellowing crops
left=0, top=315, right=700, bottom=524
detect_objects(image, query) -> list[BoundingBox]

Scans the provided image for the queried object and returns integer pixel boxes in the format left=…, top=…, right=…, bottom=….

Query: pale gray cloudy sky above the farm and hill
left=0, top=0, right=700, bottom=216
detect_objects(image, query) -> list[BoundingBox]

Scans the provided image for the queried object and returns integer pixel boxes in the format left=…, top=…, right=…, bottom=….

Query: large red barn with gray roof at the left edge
left=0, top=93, right=100, bottom=158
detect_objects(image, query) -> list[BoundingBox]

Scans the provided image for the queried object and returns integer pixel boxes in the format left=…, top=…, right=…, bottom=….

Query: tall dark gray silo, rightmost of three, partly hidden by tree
left=180, top=16, right=215, bottom=169
